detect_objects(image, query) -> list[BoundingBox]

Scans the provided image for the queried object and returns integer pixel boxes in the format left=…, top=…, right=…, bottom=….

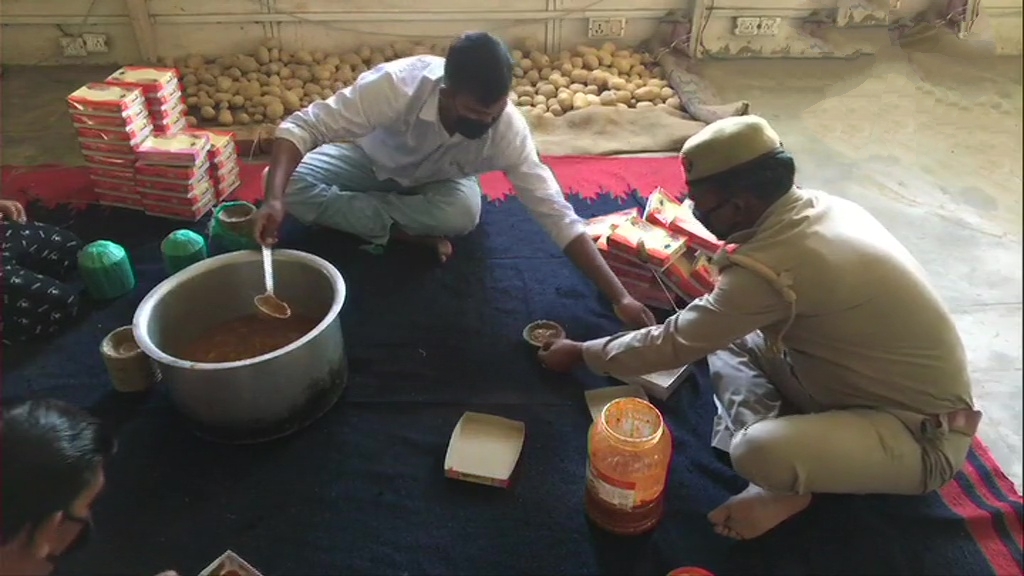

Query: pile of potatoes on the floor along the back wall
left=167, top=40, right=680, bottom=126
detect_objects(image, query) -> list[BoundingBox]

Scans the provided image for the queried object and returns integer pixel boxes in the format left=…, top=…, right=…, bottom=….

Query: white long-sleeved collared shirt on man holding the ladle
left=275, top=55, right=585, bottom=248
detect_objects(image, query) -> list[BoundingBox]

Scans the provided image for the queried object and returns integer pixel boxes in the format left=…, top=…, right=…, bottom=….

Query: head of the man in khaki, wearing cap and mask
left=679, top=116, right=797, bottom=240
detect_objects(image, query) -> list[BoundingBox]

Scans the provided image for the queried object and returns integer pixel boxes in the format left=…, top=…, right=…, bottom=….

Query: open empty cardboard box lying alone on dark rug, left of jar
left=444, top=412, right=526, bottom=488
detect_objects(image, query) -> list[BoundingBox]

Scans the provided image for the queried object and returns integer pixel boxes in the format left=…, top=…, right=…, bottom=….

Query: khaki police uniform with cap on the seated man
left=584, top=116, right=980, bottom=494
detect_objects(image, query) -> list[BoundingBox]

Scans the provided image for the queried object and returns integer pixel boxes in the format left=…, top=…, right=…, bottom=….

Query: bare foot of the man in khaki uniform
left=708, top=484, right=811, bottom=540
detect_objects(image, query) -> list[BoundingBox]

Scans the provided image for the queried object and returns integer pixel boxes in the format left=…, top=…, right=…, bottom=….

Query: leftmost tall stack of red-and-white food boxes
left=68, top=83, right=153, bottom=208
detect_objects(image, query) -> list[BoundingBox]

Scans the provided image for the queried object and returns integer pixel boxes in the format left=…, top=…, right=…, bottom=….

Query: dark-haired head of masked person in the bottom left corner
left=0, top=400, right=115, bottom=559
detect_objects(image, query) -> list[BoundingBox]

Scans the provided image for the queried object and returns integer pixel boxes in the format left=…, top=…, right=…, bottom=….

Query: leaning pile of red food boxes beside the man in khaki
left=587, top=191, right=722, bottom=310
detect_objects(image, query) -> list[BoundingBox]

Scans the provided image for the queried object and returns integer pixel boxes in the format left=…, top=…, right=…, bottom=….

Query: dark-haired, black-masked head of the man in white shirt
left=439, top=32, right=513, bottom=139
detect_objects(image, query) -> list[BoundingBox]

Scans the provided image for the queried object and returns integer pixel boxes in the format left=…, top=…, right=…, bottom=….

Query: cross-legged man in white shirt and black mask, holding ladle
left=256, top=33, right=653, bottom=327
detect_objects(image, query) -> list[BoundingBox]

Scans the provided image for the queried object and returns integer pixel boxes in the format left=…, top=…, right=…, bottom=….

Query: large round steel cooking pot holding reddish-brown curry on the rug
left=132, top=250, right=348, bottom=443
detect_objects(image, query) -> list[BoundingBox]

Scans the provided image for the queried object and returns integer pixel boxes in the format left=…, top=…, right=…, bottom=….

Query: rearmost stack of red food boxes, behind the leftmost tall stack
left=103, top=66, right=188, bottom=134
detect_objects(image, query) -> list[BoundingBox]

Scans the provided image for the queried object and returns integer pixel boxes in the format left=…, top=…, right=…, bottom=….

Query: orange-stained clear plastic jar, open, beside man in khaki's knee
left=586, top=398, right=672, bottom=536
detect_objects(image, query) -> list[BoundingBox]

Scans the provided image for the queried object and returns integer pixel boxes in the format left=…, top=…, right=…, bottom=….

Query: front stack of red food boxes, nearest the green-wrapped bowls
left=135, top=132, right=216, bottom=221
